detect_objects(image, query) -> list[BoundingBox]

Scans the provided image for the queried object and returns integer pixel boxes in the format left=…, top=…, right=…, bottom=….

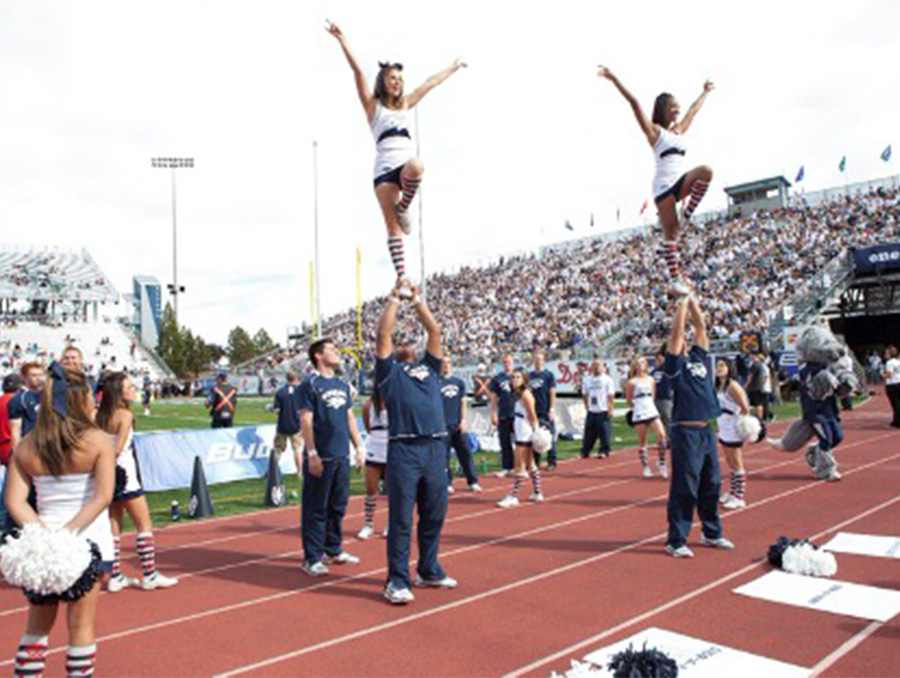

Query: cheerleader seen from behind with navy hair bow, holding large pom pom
left=0, top=362, right=115, bottom=676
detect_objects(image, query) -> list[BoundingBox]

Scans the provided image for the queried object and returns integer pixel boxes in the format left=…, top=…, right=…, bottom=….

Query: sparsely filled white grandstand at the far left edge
left=0, top=245, right=170, bottom=381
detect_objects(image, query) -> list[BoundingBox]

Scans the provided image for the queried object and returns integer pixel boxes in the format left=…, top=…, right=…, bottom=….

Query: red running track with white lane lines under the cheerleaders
left=0, top=397, right=900, bottom=676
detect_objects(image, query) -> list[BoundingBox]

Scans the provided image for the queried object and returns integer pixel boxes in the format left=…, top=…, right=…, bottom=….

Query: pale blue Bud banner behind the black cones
left=135, top=424, right=297, bottom=492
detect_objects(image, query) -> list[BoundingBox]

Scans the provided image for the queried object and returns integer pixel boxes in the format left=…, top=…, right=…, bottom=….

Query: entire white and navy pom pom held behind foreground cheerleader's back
left=0, top=523, right=100, bottom=605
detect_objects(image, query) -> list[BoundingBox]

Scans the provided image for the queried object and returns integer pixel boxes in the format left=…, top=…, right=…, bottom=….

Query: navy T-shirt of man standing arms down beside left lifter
left=298, top=372, right=353, bottom=461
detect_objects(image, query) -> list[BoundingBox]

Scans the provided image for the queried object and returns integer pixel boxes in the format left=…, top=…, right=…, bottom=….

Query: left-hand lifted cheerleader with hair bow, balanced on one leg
left=326, top=22, right=466, bottom=292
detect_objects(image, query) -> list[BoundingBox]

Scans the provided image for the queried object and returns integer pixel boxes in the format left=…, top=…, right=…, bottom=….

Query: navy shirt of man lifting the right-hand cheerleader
left=666, top=346, right=719, bottom=424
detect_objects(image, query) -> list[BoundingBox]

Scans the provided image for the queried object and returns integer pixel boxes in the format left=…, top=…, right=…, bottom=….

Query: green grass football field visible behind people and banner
left=133, top=397, right=824, bottom=526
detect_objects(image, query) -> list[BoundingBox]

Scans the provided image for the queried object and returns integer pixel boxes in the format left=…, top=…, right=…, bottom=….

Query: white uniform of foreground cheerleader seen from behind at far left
left=32, top=473, right=113, bottom=562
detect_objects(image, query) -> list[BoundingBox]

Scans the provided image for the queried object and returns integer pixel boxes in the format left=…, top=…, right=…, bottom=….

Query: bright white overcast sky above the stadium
left=0, top=0, right=900, bottom=342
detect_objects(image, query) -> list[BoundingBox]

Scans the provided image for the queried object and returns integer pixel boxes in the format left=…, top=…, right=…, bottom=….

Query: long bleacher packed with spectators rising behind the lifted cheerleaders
left=308, top=188, right=900, bottom=360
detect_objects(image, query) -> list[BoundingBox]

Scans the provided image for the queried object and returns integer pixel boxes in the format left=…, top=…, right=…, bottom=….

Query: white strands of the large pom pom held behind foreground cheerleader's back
left=0, top=523, right=92, bottom=595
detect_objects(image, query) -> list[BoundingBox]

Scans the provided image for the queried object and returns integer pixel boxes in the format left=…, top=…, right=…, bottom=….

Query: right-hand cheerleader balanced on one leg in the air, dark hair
left=597, top=66, right=713, bottom=297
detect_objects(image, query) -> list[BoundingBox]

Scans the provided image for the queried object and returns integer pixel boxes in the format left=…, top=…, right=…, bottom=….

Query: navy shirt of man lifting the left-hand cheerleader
left=375, top=351, right=447, bottom=441
